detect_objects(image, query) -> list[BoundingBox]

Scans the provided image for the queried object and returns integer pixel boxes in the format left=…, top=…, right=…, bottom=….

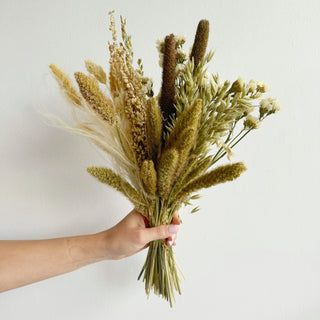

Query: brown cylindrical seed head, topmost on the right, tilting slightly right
left=190, top=20, right=209, bottom=69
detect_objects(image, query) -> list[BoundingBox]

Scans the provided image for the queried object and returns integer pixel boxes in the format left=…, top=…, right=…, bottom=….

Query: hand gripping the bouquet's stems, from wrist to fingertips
left=96, top=209, right=180, bottom=260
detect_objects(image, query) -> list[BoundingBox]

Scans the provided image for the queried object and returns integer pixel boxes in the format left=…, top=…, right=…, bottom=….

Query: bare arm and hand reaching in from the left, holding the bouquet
left=0, top=209, right=180, bottom=292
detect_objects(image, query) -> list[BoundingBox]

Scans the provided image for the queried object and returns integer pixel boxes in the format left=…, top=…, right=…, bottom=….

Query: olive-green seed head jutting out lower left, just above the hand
left=87, top=167, right=142, bottom=205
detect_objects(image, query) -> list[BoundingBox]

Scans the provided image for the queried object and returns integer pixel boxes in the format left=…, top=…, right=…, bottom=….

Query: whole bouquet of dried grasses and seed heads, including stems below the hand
left=50, top=12, right=280, bottom=306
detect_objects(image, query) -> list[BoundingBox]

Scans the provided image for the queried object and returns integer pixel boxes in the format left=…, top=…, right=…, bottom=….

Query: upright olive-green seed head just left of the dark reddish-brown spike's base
left=147, top=98, right=162, bottom=164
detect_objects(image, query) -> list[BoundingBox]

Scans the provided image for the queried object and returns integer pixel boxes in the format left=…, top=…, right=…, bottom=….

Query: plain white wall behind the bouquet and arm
left=0, top=0, right=320, bottom=320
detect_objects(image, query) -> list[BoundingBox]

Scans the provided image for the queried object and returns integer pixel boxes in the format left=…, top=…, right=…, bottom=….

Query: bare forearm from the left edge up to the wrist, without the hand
left=0, top=233, right=108, bottom=292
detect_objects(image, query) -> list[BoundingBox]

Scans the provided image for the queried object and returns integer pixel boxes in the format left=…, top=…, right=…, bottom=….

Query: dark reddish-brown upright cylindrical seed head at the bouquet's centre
left=159, top=34, right=176, bottom=129
